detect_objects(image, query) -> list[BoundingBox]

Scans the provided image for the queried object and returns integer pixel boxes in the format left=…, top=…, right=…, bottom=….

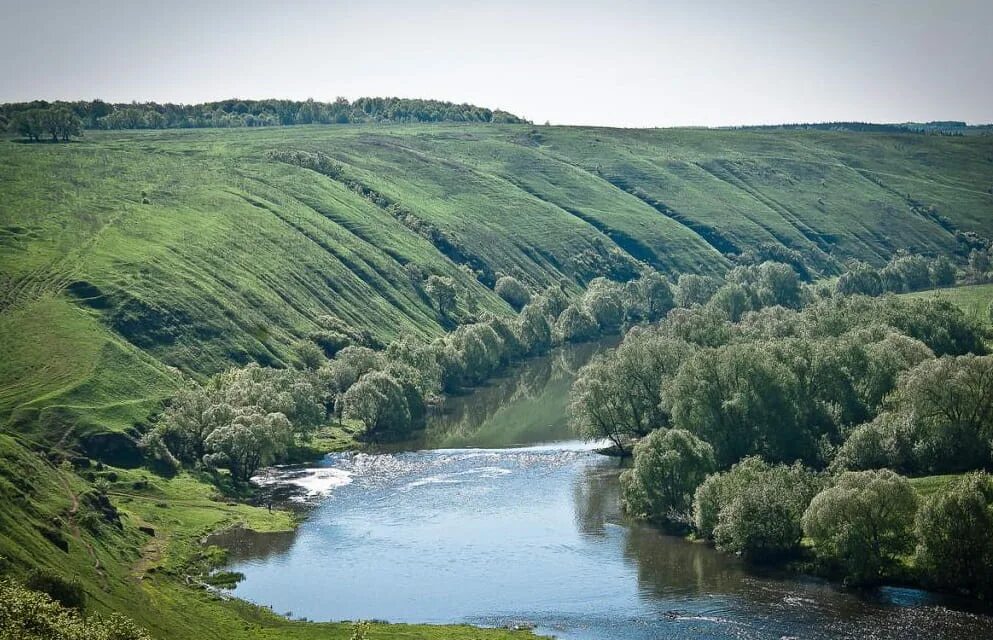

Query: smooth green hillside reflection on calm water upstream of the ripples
left=424, top=342, right=610, bottom=446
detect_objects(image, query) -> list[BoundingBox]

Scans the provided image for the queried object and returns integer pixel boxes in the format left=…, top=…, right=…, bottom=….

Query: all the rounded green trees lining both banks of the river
left=144, top=256, right=993, bottom=596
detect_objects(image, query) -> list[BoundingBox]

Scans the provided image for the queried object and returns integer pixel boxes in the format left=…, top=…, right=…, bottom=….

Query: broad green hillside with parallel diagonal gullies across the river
left=0, top=124, right=993, bottom=439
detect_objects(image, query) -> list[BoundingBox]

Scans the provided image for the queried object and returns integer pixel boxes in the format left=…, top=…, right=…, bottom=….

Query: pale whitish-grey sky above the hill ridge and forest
left=0, top=0, right=993, bottom=127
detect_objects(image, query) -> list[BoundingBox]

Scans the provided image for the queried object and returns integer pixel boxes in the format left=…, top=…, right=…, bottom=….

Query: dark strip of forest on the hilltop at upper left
left=0, top=98, right=526, bottom=130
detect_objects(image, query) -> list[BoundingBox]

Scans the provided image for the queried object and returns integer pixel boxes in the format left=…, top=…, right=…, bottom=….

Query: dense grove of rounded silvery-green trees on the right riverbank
left=584, top=296, right=993, bottom=595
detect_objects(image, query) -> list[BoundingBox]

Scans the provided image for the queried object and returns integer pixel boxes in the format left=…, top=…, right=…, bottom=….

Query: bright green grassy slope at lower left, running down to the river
left=0, top=434, right=529, bottom=640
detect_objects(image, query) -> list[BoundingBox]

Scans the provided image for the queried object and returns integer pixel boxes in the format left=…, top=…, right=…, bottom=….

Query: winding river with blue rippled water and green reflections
left=217, top=340, right=993, bottom=640
